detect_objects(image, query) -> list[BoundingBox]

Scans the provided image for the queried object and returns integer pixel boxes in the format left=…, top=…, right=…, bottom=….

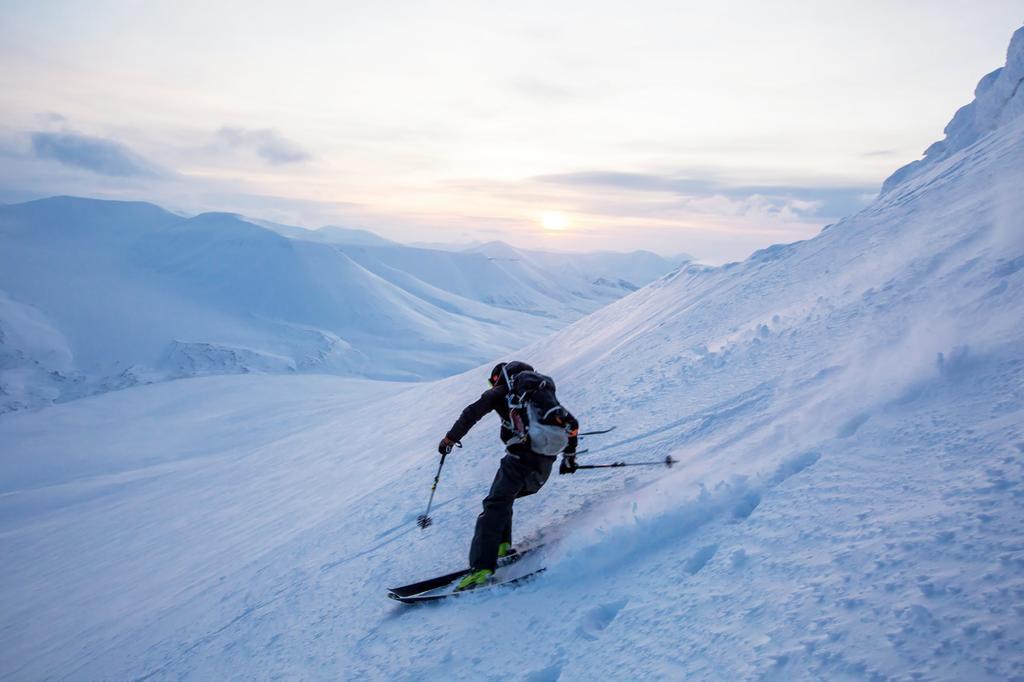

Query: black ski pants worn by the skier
left=469, top=453, right=556, bottom=570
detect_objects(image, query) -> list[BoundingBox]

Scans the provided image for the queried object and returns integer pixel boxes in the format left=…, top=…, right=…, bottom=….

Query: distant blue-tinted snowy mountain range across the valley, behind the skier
left=0, top=198, right=688, bottom=411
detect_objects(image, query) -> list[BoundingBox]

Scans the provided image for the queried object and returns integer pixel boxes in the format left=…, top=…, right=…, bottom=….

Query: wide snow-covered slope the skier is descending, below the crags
left=0, top=26, right=1024, bottom=681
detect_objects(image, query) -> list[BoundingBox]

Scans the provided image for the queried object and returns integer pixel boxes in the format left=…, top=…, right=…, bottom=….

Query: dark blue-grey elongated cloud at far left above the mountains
left=31, top=132, right=165, bottom=177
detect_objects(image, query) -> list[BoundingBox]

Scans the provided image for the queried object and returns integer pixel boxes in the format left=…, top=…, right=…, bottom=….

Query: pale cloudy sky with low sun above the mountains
left=0, top=0, right=1024, bottom=263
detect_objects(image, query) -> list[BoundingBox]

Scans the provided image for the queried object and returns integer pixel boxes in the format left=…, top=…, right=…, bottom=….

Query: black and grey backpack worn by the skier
left=506, top=372, right=569, bottom=457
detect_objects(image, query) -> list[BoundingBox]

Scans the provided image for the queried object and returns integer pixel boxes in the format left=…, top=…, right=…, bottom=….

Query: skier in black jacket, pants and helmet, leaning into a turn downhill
left=437, top=360, right=580, bottom=591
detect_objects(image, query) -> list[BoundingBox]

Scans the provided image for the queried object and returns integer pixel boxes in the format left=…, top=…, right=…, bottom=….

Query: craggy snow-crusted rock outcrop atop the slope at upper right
left=882, top=27, right=1024, bottom=194
